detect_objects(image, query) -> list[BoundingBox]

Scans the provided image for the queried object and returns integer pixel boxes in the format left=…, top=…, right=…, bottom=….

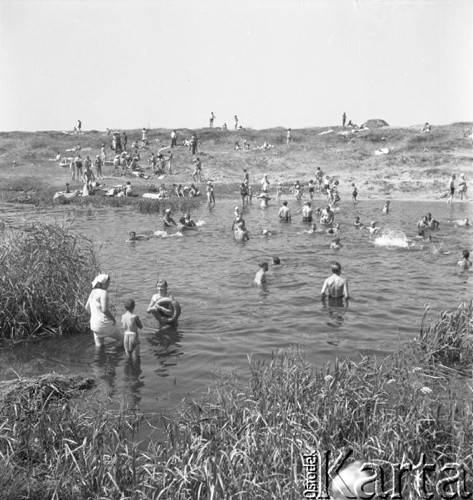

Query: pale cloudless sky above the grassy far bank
left=0, top=0, right=473, bottom=131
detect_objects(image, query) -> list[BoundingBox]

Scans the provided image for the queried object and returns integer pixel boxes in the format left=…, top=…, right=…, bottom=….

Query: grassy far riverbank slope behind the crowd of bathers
left=0, top=123, right=473, bottom=211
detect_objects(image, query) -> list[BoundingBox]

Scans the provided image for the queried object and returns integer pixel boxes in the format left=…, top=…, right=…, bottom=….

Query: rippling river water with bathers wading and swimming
left=0, top=199, right=472, bottom=412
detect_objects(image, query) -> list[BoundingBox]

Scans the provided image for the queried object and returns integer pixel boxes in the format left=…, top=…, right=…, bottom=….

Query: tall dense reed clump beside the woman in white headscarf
left=0, top=223, right=98, bottom=340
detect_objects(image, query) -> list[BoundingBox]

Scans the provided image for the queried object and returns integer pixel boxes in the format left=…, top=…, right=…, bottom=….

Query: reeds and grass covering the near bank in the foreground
left=0, top=304, right=473, bottom=500
